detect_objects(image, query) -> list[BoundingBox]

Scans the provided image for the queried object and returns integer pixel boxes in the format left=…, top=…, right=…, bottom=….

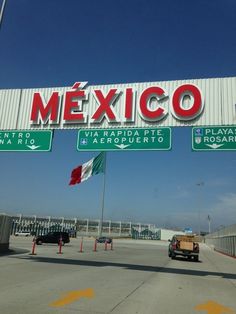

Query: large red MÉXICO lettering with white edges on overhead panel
left=30, top=82, right=204, bottom=124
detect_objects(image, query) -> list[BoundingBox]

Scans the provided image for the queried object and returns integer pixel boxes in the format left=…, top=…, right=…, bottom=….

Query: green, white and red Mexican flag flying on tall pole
left=69, top=153, right=105, bottom=185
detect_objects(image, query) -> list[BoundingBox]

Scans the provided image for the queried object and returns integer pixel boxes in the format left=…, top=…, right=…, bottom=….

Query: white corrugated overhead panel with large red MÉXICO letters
left=0, top=77, right=236, bottom=130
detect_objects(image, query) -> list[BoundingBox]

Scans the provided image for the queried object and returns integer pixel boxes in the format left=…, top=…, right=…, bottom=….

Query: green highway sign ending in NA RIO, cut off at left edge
left=0, top=130, right=52, bottom=152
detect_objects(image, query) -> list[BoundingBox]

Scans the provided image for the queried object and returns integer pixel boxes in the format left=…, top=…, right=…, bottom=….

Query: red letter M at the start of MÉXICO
left=30, top=92, right=60, bottom=124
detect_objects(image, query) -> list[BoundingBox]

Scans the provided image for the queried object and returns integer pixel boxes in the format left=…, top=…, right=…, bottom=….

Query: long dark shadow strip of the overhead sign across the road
left=13, top=256, right=236, bottom=279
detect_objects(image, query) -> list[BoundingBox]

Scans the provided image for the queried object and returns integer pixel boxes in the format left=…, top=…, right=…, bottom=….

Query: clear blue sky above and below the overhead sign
left=0, top=0, right=236, bottom=230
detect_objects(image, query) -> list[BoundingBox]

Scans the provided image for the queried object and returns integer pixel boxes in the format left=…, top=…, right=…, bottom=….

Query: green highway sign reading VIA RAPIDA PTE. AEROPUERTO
left=77, top=127, right=171, bottom=151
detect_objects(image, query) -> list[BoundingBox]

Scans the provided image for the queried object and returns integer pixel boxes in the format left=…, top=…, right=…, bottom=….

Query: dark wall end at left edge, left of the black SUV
left=0, top=214, right=12, bottom=252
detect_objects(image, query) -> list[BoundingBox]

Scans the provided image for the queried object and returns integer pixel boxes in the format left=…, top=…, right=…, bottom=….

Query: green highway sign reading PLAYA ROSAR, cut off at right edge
left=192, top=126, right=236, bottom=151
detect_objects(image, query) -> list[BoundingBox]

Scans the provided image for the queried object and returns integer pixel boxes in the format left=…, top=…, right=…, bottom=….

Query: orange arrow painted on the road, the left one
left=49, top=288, right=95, bottom=307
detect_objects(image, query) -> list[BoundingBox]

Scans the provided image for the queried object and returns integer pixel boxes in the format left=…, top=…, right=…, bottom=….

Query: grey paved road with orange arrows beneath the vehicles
left=0, top=237, right=236, bottom=314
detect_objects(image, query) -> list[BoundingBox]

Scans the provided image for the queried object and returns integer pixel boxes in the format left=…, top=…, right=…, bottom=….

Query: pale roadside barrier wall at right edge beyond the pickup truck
left=205, top=224, right=236, bottom=258
